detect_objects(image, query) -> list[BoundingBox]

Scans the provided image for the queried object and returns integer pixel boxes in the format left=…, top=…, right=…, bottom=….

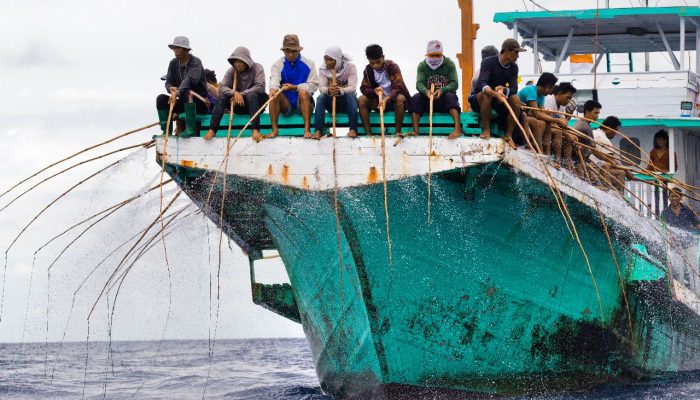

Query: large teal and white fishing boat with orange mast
left=156, top=1, right=700, bottom=399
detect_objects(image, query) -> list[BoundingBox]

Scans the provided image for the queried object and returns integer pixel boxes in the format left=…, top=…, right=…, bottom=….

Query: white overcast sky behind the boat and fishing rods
left=0, top=0, right=694, bottom=342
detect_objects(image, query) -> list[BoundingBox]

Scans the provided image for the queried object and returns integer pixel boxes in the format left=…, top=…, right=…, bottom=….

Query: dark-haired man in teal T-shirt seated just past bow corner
left=518, top=72, right=567, bottom=155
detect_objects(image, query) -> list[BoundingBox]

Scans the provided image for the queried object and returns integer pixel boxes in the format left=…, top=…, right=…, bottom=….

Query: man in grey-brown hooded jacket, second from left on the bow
left=204, top=47, right=268, bottom=140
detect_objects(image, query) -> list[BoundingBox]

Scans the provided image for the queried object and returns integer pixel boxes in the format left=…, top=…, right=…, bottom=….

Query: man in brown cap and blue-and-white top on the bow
left=265, top=34, right=321, bottom=139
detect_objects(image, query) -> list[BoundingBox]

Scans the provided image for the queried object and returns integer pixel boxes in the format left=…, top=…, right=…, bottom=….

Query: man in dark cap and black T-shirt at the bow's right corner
left=469, top=39, right=525, bottom=148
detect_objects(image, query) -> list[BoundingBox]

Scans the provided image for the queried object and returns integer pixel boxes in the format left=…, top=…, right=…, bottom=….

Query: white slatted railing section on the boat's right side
left=625, top=174, right=673, bottom=219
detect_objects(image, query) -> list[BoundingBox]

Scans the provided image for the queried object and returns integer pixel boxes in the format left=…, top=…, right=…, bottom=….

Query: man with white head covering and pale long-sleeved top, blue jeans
left=315, top=46, right=357, bottom=138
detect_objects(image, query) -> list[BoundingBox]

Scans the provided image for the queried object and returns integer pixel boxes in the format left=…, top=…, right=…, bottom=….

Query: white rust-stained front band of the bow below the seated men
left=156, top=135, right=504, bottom=190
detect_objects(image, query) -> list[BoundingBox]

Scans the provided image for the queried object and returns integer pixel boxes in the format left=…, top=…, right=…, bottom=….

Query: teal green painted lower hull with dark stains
left=165, top=164, right=700, bottom=398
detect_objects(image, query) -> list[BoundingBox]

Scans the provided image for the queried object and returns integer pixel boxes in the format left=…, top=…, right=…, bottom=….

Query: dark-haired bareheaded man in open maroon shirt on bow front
left=359, top=44, right=411, bottom=135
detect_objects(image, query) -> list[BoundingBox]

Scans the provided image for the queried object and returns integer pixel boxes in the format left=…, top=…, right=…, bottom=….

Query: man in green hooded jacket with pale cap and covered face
left=408, top=40, right=462, bottom=139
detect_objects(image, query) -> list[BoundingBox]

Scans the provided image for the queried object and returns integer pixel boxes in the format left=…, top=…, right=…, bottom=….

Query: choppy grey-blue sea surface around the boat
left=0, top=339, right=700, bottom=400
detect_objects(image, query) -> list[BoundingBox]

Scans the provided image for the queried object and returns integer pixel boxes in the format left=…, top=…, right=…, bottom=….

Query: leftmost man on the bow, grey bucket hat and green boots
left=156, top=36, right=209, bottom=135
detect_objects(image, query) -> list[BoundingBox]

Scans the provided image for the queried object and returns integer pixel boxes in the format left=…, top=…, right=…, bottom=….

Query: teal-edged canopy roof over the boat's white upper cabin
left=493, top=7, right=700, bottom=61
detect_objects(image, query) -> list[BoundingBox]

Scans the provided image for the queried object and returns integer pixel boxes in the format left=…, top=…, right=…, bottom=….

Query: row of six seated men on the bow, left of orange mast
left=156, top=34, right=462, bottom=140
